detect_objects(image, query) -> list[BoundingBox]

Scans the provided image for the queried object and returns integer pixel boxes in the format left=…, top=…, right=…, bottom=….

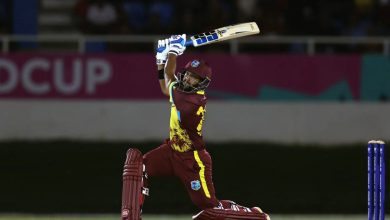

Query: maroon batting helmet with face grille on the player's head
left=176, top=59, right=212, bottom=92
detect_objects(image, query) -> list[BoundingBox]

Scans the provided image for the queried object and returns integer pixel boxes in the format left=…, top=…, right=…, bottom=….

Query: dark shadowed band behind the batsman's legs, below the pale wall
left=0, top=141, right=376, bottom=214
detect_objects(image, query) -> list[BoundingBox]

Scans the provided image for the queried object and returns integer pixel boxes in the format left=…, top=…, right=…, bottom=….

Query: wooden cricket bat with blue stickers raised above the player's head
left=186, top=22, right=260, bottom=47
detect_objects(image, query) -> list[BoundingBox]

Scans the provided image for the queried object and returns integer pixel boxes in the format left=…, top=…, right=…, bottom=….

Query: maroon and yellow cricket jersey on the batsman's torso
left=169, top=82, right=206, bottom=152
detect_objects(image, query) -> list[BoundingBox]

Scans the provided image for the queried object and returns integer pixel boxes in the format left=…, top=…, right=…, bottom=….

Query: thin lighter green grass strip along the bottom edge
left=0, top=214, right=367, bottom=220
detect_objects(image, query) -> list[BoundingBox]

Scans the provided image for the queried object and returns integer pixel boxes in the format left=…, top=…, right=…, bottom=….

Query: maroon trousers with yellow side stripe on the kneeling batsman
left=143, top=142, right=219, bottom=209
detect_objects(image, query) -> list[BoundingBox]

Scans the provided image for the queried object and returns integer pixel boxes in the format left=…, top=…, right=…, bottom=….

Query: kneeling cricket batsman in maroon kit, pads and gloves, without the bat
left=122, top=34, right=270, bottom=220
